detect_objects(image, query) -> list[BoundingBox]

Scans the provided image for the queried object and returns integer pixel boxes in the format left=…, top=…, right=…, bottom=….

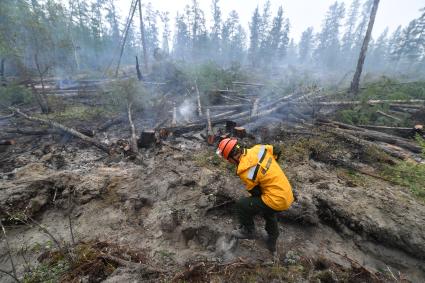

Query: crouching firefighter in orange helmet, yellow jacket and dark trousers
left=217, top=138, right=294, bottom=253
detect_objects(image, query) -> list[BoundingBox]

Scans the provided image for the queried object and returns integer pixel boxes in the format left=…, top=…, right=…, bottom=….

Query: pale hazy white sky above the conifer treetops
left=118, top=0, right=425, bottom=40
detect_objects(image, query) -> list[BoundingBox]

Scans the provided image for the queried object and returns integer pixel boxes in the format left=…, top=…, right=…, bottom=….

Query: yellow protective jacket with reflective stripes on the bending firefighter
left=237, top=145, right=294, bottom=211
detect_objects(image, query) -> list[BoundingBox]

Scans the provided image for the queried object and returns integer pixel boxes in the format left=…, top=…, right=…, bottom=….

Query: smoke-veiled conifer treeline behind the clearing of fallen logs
left=0, top=0, right=425, bottom=80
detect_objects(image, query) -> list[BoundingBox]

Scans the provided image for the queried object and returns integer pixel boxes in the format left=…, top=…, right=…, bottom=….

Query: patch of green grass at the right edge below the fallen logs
left=382, top=161, right=425, bottom=201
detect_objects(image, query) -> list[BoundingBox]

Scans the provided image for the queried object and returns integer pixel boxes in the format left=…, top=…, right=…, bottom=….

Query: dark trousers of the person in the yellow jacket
left=235, top=197, right=279, bottom=239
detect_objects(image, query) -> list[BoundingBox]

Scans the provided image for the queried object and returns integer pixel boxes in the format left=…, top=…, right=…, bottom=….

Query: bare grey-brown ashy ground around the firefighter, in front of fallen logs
left=0, top=112, right=425, bottom=282
